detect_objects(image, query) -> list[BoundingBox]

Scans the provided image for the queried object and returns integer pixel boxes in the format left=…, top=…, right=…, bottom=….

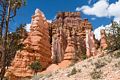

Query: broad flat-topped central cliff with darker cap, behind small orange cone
left=49, top=12, right=92, bottom=64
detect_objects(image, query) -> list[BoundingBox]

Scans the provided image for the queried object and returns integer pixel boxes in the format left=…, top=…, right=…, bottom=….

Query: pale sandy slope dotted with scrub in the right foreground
left=32, top=50, right=120, bottom=80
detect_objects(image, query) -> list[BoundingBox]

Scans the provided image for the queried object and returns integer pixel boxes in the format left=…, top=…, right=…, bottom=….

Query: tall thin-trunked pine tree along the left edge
left=0, top=0, right=26, bottom=80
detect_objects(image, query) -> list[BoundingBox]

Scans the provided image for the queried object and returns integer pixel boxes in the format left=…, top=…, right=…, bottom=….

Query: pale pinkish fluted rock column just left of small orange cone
left=52, top=29, right=67, bottom=63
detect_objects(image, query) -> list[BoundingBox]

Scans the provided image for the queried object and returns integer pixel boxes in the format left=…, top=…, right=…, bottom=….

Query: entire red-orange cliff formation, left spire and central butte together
left=7, top=9, right=105, bottom=80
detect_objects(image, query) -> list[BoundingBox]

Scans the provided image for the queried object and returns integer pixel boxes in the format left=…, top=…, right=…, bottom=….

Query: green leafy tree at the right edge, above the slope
left=106, top=22, right=120, bottom=51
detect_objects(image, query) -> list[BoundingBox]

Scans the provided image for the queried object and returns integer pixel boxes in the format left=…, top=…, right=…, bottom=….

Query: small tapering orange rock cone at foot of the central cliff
left=59, top=33, right=76, bottom=68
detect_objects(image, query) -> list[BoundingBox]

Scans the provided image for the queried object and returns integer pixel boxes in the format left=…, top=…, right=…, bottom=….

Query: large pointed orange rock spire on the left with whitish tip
left=8, top=9, right=52, bottom=80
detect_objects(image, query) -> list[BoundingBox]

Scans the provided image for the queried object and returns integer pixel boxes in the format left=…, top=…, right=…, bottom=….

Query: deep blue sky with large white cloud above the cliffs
left=10, top=0, right=120, bottom=39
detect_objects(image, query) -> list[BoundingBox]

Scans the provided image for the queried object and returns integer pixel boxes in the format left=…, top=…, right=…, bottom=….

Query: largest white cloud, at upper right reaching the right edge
left=76, top=0, right=120, bottom=21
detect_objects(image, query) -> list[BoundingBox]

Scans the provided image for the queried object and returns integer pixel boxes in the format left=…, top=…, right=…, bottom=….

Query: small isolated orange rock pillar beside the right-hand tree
left=100, top=29, right=108, bottom=50
